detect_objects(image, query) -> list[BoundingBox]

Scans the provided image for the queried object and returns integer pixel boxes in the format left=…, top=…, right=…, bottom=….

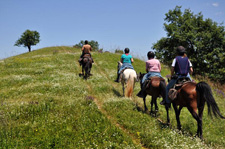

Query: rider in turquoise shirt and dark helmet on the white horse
left=115, top=48, right=134, bottom=82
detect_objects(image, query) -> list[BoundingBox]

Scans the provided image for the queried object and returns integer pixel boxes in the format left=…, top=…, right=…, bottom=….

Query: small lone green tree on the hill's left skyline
left=14, top=30, right=40, bottom=52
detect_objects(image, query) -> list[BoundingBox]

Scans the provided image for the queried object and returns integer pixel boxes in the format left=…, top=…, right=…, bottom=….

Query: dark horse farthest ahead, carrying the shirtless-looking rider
left=81, top=55, right=92, bottom=79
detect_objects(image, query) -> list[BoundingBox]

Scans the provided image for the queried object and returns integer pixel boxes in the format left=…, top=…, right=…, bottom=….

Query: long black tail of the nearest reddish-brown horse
left=196, top=82, right=225, bottom=119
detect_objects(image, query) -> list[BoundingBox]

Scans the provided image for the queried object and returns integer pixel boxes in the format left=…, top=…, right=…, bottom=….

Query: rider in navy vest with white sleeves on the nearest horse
left=160, top=46, right=193, bottom=105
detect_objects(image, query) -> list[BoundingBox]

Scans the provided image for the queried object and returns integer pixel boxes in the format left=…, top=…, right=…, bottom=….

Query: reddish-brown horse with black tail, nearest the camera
left=167, top=82, right=225, bottom=139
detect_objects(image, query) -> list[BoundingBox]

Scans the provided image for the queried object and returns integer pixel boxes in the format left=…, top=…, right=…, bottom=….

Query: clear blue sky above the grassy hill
left=0, top=0, right=225, bottom=59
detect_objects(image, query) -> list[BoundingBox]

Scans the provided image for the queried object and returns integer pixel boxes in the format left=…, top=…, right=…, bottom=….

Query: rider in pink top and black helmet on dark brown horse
left=137, top=51, right=162, bottom=97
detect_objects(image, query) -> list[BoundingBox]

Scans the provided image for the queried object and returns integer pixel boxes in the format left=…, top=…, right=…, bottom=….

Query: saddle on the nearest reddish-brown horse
left=168, top=77, right=191, bottom=101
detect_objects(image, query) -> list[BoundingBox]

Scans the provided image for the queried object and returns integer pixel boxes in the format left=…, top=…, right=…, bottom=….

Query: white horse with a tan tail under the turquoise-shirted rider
left=118, top=62, right=138, bottom=98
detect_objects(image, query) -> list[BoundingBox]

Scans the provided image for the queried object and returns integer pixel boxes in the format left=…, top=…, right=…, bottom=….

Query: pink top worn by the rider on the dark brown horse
left=146, top=58, right=161, bottom=72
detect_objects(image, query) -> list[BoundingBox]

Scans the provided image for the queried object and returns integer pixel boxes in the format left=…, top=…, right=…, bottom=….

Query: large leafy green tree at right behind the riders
left=153, top=6, right=225, bottom=82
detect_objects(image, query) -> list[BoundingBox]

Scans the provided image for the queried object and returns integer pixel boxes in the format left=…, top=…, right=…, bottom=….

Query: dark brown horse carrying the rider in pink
left=139, top=72, right=169, bottom=118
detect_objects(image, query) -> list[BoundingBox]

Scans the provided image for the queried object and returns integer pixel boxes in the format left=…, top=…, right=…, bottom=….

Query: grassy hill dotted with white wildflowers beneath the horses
left=0, top=47, right=225, bottom=148
